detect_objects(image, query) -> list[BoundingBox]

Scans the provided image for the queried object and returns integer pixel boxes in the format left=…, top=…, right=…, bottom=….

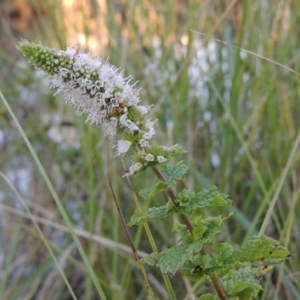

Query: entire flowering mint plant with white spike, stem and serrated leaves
left=18, top=41, right=290, bottom=300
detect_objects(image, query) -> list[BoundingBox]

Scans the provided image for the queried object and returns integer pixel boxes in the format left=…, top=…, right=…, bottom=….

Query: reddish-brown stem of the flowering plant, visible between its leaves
left=152, top=166, right=228, bottom=300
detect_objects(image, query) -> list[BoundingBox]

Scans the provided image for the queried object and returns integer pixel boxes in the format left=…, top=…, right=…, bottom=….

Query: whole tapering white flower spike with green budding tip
left=18, top=41, right=168, bottom=176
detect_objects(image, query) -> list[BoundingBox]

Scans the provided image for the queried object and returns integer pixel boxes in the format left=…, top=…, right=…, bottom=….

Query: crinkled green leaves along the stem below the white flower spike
left=129, top=162, right=290, bottom=300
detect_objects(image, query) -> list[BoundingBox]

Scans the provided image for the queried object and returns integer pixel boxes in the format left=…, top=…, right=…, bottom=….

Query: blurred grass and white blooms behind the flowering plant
left=0, top=0, right=300, bottom=300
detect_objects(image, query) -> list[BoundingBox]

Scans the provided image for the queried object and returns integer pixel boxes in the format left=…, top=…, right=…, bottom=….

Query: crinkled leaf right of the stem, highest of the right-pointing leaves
left=176, top=186, right=232, bottom=217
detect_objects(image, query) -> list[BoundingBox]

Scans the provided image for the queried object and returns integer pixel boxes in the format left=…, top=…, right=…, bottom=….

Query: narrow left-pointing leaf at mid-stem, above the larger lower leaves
left=128, top=201, right=175, bottom=228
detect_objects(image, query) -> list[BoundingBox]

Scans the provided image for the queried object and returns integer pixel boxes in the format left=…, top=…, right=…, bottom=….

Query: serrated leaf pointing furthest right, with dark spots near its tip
left=232, top=235, right=290, bottom=266
